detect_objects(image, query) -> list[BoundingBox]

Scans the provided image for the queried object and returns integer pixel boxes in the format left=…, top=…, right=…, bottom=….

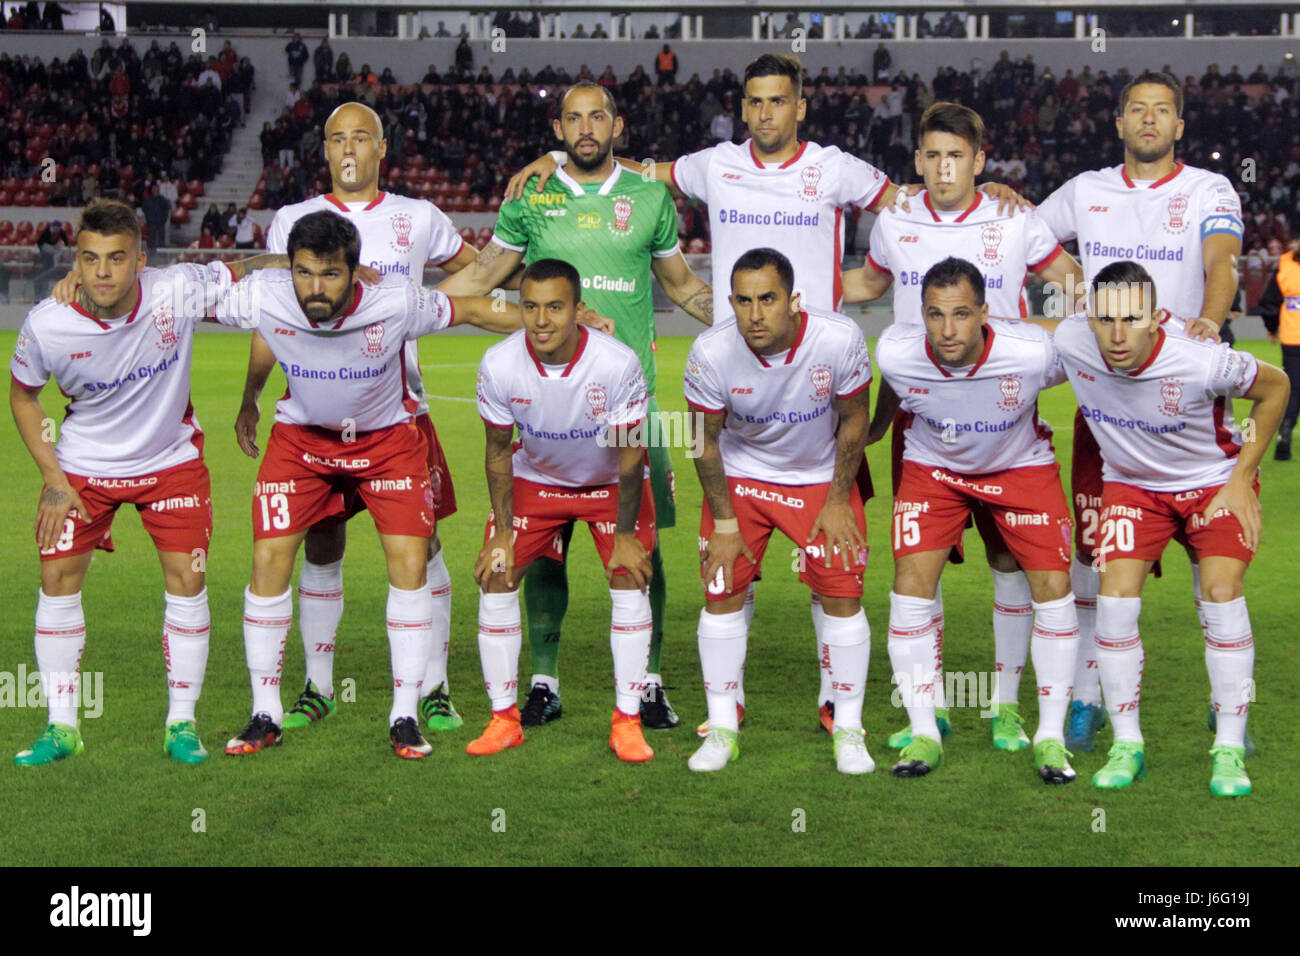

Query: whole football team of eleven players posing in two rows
left=0, top=7, right=1300, bottom=879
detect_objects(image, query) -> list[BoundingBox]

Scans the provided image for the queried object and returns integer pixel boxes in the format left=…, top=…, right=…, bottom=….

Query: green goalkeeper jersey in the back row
left=494, top=164, right=677, bottom=395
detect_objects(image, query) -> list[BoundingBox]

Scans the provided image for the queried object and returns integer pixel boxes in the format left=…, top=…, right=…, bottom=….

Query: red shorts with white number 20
left=1097, top=480, right=1260, bottom=564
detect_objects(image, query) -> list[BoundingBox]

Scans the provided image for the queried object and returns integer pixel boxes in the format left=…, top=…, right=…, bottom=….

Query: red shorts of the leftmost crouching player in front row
left=40, top=458, right=212, bottom=561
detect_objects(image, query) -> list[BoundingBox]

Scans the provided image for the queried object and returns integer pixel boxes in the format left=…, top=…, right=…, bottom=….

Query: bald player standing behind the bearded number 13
left=235, top=103, right=477, bottom=730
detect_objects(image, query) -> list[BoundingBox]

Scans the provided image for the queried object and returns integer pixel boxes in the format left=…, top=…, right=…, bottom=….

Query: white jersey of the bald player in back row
left=267, top=193, right=465, bottom=415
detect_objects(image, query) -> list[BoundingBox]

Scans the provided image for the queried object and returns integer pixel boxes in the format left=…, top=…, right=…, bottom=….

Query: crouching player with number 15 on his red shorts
left=876, top=258, right=1079, bottom=783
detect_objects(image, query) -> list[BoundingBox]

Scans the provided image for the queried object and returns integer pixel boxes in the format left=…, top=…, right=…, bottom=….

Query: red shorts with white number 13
left=252, top=421, right=436, bottom=541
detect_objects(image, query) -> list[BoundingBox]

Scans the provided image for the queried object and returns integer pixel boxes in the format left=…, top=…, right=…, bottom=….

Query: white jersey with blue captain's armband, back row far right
left=1039, top=163, right=1243, bottom=319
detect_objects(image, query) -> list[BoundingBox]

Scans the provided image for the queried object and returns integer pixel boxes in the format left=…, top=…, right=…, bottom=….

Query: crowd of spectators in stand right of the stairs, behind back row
left=253, top=44, right=1300, bottom=261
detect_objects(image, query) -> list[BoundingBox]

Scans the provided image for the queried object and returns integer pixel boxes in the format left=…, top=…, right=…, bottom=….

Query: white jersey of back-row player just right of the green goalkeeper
left=672, top=139, right=889, bottom=316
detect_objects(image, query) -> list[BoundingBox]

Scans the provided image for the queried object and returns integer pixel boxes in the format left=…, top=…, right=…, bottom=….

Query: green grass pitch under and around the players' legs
left=0, top=332, right=1300, bottom=866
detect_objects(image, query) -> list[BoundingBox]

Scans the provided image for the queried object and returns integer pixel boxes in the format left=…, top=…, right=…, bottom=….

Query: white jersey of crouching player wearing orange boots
left=478, top=325, right=647, bottom=494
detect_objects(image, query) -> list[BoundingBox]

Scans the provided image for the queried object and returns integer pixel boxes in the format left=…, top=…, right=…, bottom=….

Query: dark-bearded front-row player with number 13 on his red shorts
left=218, top=211, right=533, bottom=760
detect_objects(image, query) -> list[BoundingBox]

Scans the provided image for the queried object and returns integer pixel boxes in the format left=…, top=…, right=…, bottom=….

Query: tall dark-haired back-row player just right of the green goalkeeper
left=506, top=53, right=1021, bottom=736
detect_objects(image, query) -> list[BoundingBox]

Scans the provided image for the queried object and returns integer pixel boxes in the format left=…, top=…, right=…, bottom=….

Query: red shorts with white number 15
left=893, top=462, right=1071, bottom=571
